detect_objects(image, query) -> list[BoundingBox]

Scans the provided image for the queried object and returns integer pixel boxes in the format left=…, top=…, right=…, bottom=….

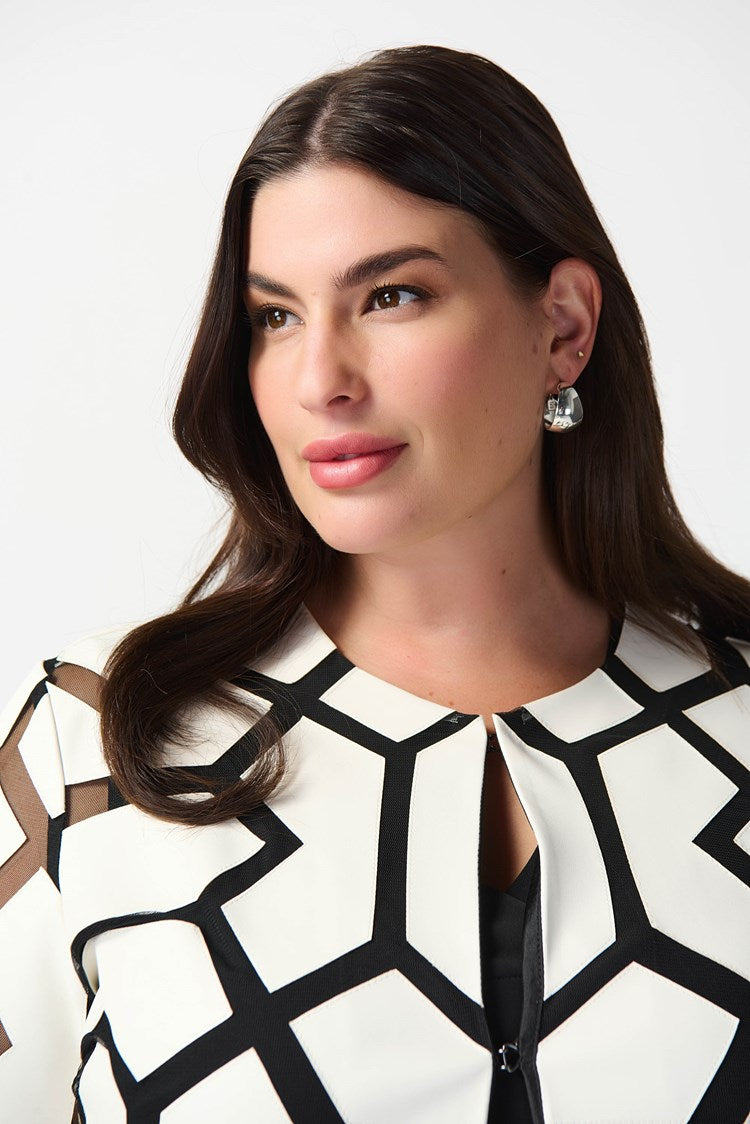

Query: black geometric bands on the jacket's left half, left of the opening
left=67, top=653, right=490, bottom=1124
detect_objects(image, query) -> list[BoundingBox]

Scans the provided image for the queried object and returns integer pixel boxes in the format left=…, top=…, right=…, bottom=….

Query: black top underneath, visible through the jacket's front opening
left=479, top=849, right=539, bottom=1124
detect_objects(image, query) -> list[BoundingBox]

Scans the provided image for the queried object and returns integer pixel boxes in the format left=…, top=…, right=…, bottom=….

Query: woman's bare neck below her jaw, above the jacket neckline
left=307, top=478, right=604, bottom=665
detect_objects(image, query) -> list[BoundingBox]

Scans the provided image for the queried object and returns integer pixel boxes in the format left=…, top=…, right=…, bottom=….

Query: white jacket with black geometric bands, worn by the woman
left=0, top=606, right=750, bottom=1124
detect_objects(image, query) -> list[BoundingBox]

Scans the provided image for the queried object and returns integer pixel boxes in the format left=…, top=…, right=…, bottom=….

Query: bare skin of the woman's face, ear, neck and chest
left=245, top=165, right=611, bottom=889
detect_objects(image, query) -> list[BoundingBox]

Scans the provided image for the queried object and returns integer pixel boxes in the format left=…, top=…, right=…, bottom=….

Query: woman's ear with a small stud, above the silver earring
left=542, top=257, right=602, bottom=395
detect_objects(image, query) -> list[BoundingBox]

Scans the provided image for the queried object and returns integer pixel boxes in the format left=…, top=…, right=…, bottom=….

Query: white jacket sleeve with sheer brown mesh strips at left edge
left=0, top=660, right=91, bottom=1124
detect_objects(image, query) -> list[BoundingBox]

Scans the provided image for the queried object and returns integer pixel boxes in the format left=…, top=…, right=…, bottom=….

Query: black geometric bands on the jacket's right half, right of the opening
left=503, top=641, right=750, bottom=1122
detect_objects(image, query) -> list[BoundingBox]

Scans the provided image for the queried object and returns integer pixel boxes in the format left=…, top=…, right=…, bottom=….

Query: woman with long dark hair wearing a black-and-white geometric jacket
left=0, top=46, right=750, bottom=1124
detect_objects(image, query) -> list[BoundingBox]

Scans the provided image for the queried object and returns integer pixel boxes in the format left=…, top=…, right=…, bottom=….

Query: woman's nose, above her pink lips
left=296, top=324, right=367, bottom=414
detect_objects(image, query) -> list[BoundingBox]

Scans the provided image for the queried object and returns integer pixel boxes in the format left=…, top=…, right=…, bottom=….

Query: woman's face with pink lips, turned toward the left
left=245, top=165, right=555, bottom=554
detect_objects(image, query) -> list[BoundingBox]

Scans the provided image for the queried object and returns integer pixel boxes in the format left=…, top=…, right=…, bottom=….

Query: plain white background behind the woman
left=0, top=0, right=750, bottom=699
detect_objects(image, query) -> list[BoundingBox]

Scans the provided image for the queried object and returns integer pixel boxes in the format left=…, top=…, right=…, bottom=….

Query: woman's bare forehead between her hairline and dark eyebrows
left=247, top=164, right=479, bottom=271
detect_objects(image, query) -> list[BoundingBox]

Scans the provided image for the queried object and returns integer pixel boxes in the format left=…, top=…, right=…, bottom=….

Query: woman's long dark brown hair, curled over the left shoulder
left=96, top=46, right=750, bottom=824
